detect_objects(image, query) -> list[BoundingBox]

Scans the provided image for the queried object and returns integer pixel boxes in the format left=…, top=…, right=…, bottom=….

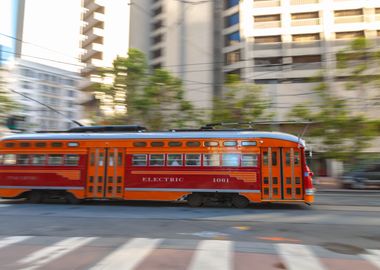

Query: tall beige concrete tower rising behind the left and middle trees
left=130, top=0, right=217, bottom=109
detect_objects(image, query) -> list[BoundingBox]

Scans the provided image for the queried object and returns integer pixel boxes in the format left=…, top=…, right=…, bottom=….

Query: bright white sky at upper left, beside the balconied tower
left=0, top=0, right=81, bottom=71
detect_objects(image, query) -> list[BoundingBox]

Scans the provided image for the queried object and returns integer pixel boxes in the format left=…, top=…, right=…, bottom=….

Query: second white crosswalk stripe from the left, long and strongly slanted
left=18, top=237, right=96, bottom=270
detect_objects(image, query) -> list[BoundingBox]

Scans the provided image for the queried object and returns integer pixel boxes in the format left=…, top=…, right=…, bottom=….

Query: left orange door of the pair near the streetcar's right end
left=261, top=147, right=282, bottom=200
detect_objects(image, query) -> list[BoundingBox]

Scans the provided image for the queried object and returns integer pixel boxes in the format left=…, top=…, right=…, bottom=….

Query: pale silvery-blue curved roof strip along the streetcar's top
left=0, top=131, right=305, bottom=146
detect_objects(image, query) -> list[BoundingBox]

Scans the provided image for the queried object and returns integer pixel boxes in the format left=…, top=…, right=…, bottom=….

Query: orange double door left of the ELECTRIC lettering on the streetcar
left=86, top=147, right=124, bottom=199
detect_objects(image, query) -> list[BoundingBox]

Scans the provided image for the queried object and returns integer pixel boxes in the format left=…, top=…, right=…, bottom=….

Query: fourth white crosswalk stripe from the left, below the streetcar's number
left=188, top=240, right=233, bottom=270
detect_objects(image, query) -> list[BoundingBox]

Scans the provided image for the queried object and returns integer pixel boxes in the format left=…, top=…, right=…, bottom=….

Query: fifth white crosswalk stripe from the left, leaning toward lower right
left=276, top=244, right=326, bottom=270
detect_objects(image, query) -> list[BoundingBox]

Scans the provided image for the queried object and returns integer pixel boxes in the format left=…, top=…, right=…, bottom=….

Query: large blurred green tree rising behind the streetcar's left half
left=97, top=49, right=194, bottom=130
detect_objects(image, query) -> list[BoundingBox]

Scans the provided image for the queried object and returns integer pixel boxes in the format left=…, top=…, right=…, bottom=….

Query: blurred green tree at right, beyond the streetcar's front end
left=290, top=39, right=378, bottom=164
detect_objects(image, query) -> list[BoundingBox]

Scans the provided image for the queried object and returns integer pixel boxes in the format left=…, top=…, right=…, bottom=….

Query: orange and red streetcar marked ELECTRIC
left=0, top=126, right=314, bottom=207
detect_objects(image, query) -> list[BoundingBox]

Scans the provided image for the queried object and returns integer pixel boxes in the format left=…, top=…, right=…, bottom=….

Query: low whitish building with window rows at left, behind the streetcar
left=7, top=59, right=82, bottom=131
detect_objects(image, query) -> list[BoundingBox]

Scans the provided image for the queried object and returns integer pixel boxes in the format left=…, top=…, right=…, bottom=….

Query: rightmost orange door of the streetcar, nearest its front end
left=282, top=148, right=303, bottom=200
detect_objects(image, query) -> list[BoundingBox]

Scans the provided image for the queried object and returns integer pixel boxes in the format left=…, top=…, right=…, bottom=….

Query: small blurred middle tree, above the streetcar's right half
left=212, top=75, right=272, bottom=123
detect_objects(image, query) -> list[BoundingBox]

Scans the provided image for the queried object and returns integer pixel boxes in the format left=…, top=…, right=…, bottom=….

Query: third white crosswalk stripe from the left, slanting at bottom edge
left=91, top=238, right=162, bottom=270
